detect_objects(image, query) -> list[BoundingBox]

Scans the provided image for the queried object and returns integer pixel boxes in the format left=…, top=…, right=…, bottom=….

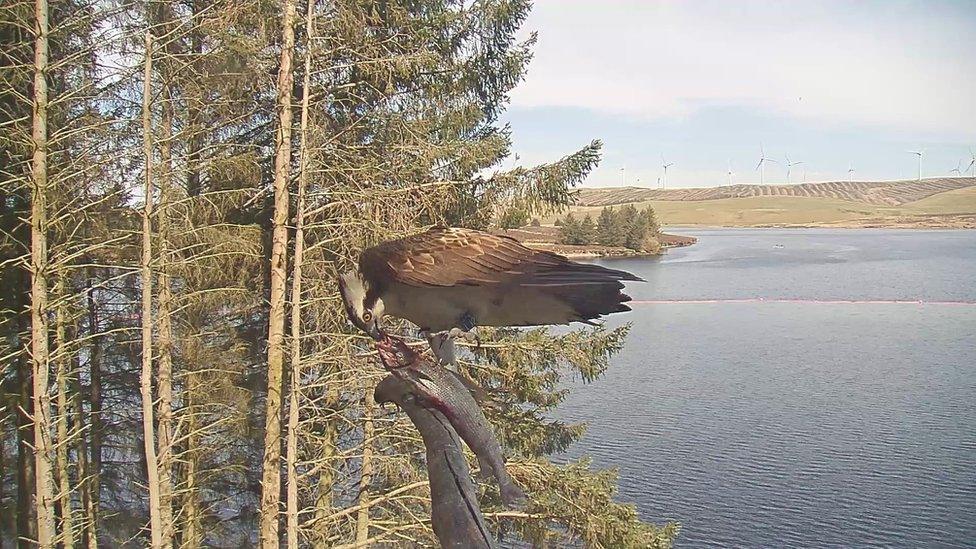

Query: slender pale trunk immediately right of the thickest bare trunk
left=286, top=0, right=315, bottom=549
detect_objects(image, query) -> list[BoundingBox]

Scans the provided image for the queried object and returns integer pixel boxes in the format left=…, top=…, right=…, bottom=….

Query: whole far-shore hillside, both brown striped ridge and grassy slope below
left=571, top=178, right=976, bottom=228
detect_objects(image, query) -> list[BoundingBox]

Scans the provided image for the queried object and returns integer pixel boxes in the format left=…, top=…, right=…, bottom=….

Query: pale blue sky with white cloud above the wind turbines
left=504, top=0, right=976, bottom=188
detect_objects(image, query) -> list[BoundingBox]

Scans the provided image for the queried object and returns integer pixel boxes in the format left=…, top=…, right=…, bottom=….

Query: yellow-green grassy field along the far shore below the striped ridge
left=548, top=186, right=976, bottom=228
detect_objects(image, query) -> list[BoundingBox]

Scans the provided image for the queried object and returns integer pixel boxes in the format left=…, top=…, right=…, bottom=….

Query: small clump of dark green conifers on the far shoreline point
left=556, top=204, right=661, bottom=251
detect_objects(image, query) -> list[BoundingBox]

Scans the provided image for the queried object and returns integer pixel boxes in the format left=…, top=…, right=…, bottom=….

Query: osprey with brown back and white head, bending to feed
left=339, top=227, right=641, bottom=342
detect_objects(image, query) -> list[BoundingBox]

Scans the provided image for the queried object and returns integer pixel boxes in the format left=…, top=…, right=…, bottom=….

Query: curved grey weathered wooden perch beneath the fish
left=373, top=374, right=495, bottom=549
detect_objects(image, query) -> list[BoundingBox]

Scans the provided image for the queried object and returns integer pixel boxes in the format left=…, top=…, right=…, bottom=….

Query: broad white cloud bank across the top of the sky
left=512, top=0, right=976, bottom=135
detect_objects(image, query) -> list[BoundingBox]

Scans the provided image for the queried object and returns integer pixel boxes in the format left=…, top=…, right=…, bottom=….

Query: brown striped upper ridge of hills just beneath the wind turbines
left=576, top=177, right=976, bottom=206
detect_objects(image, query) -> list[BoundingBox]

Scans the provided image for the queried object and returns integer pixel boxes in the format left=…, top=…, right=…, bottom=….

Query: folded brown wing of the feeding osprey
left=359, top=228, right=640, bottom=287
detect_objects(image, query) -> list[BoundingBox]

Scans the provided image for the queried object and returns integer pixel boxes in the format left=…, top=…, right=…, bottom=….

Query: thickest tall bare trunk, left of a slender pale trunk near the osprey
left=260, top=0, right=295, bottom=548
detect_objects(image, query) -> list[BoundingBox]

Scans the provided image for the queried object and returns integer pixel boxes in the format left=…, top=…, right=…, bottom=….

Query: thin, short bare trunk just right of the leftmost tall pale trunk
left=54, top=274, right=75, bottom=547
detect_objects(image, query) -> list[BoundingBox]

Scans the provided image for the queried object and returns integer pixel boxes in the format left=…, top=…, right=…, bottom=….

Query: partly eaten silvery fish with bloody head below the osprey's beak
left=376, top=334, right=526, bottom=508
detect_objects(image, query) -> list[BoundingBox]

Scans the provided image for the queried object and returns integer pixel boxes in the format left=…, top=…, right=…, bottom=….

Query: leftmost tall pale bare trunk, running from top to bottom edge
left=31, top=0, right=55, bottom=548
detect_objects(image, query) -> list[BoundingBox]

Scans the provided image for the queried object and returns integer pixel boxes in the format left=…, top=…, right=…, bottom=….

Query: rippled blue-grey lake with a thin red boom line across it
left=558, top=229, right=976, bottom=548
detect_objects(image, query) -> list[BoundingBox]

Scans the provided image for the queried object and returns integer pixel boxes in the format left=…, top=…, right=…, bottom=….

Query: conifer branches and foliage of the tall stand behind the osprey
left=0, top=0, right=676, bottom=548
